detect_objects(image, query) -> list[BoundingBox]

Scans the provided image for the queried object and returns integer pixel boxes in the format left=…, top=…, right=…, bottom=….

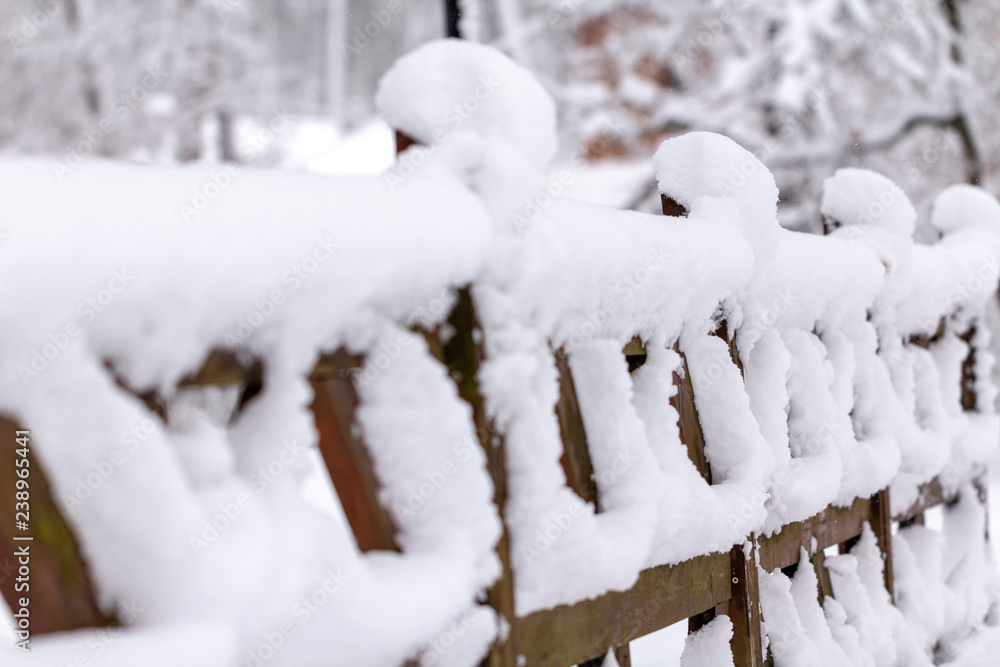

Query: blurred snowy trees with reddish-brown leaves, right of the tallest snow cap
left=502, top=0, right=1000, bottom=227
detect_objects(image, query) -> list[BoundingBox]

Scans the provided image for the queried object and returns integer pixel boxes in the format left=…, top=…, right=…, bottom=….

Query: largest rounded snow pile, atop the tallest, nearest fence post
left=375, top=39, right=557, bottom=168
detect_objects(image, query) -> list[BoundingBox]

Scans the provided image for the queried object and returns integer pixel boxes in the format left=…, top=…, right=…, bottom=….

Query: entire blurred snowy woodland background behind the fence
left=0, top=0, right=1000, bottom=218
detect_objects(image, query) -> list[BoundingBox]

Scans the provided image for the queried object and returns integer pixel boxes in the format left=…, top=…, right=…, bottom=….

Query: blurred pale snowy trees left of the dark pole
left=0, top=0, right=444, bottom=163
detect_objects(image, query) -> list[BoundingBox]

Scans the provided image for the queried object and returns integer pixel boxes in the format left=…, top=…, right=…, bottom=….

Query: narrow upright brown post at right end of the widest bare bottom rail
left=727, top=535, right=765, bottom=667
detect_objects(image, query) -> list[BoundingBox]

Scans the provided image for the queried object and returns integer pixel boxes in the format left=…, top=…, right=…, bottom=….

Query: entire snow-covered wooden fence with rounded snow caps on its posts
left=0, top=37, right=1000, bottom=667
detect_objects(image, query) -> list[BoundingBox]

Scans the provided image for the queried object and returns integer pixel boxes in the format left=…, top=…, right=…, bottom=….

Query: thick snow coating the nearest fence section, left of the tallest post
left=0, top=159, right=499, bottom=667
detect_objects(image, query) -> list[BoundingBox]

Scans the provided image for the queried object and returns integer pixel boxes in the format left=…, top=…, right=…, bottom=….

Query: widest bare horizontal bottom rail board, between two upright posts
left=517, top=553, right=731, bottom=667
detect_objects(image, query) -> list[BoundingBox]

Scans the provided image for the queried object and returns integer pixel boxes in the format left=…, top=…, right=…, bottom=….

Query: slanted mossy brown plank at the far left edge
left=0, top=417, right=116, bottom=641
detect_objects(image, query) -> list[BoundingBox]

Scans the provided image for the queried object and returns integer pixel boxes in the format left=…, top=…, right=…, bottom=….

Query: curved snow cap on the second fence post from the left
left=653, top=132, right=779, bottom=265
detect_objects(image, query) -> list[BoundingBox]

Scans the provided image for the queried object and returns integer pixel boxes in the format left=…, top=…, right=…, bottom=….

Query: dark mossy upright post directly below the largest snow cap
left=439, top=287, right=519, bottom=667
